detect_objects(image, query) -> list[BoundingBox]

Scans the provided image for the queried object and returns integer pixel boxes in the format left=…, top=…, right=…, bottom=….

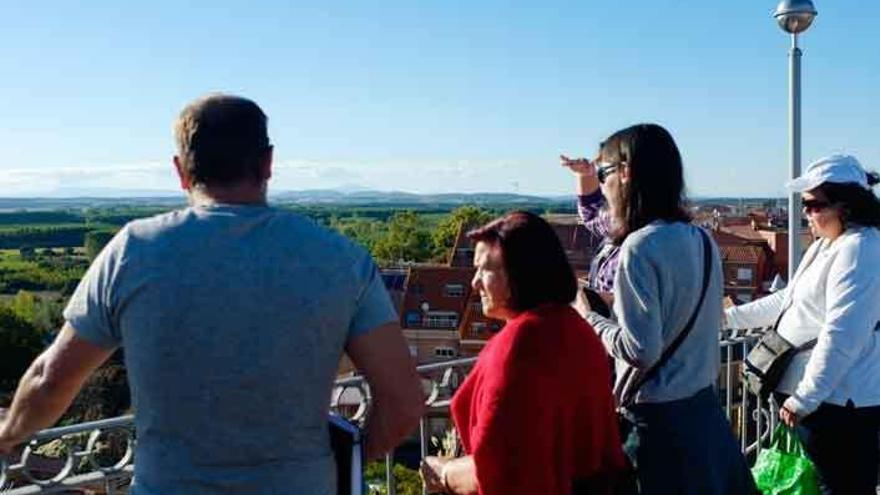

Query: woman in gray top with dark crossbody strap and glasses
left=580, top=124, right=755, bottom=495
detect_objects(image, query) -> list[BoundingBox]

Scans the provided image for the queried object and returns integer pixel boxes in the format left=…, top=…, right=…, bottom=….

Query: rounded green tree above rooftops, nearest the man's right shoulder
left=373, top=211, right=431, bottom=263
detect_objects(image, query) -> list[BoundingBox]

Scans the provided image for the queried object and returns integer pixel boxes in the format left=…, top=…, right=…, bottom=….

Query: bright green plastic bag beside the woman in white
left=752, top=423, right=819, bottom=495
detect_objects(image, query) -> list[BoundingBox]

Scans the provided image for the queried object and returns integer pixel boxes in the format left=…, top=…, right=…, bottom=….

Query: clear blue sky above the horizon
left=0, top=0, right=880, bottom=196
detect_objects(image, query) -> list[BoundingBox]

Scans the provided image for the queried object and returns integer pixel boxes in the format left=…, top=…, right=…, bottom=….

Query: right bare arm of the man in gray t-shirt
left=346, top=323, right=424, bottom=459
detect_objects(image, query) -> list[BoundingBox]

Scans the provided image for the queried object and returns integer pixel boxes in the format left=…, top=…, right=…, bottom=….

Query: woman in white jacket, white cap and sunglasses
left=726, top=155, right=880, bottom=495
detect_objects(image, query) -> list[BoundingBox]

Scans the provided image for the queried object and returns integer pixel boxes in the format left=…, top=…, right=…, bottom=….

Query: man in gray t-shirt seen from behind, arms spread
left=0, top=95, right=421, bottom=495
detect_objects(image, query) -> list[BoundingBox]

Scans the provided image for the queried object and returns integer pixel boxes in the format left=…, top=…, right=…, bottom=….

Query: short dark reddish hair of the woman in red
left=467, top=211, right=577, bottom=311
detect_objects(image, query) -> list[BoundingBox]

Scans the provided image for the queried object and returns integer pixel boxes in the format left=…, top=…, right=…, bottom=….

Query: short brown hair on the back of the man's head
left=174, top=94, right=271, bottom=186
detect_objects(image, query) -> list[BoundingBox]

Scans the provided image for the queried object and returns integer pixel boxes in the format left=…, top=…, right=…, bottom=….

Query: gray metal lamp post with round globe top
left=773, top=0, right=818, bottom=283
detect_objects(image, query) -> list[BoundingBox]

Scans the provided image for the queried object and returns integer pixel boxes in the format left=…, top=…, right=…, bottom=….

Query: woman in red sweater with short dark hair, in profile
left=422, top=212, right=625, bottom=495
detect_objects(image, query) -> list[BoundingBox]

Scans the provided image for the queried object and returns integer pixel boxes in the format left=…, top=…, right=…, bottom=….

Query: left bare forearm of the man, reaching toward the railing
left=0, top=323, right=114, bottom=455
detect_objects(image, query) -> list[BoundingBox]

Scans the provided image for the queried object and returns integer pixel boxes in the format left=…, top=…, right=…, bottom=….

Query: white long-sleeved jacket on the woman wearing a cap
left=726, top=227, right=880, bottom=417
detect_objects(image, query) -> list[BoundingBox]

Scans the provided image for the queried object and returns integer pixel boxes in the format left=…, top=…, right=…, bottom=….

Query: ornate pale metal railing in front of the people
left=0, top=330, right=777, bottom=495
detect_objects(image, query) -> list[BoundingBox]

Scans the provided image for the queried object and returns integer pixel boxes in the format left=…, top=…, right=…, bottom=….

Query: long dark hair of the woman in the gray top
left=600, top=124, right=691, bottom=244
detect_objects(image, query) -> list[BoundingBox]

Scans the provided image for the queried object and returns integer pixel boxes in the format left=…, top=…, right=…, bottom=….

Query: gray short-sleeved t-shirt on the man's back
left=64, top=205, right=397, bottom=495
